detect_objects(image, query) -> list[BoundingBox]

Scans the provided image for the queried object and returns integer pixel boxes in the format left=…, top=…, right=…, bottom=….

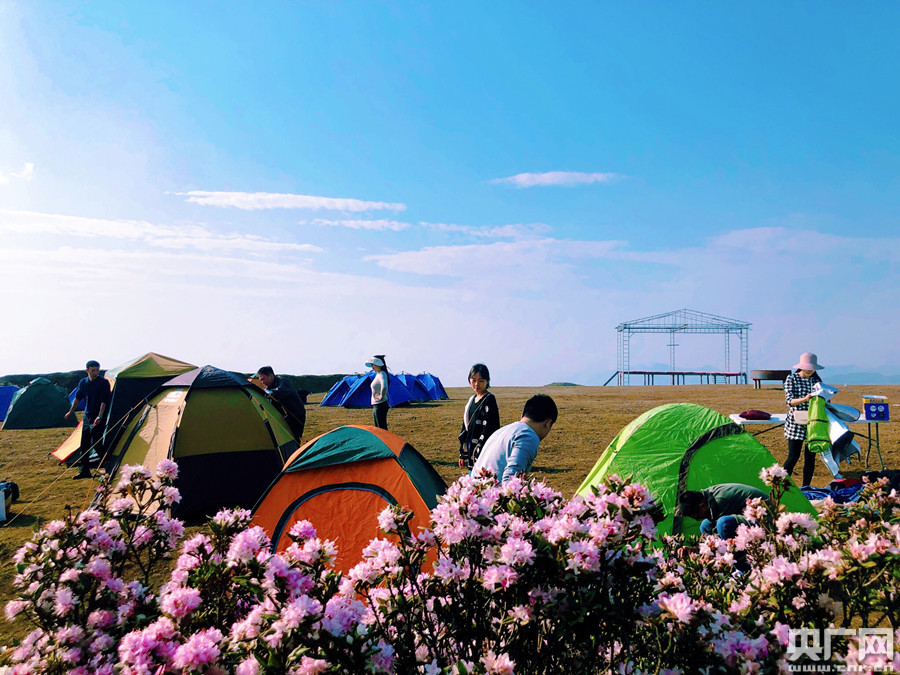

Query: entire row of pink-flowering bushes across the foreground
left=0, top=462, right=900, bottom=675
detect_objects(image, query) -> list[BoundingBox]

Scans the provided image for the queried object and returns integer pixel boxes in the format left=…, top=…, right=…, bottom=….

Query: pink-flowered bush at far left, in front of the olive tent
left=6, top=460, right=184, bottom=673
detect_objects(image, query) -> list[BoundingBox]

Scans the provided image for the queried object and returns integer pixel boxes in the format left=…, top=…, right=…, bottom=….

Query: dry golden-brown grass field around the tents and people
left=0, top=385, right=900, bottom=644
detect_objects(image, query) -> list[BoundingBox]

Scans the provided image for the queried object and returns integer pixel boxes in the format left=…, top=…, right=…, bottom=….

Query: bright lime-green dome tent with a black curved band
left=576, top=403, right=816, bottom=534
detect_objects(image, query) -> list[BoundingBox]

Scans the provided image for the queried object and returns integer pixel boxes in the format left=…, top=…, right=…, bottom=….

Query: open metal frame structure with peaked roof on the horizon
left=610, top=309, right=751, bottom=385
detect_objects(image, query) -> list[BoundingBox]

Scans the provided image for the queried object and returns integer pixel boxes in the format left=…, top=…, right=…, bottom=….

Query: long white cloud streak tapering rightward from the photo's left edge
left=0, top=209, right=322, bottom=255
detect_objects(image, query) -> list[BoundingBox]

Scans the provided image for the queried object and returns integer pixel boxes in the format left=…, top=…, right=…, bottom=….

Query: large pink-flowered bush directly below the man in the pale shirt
left=348, top=474, right=655, bottom=673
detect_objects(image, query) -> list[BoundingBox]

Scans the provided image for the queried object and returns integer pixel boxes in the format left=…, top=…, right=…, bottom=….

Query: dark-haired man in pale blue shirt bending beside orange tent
left=472, top=394, right=559, bottom=483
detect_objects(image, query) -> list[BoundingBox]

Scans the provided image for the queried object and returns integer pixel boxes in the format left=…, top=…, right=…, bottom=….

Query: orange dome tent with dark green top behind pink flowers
left=253, top=426, right=447, bottom=572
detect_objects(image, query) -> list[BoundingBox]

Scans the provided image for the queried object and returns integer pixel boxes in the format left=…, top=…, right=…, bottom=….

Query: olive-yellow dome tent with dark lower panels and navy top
left=108, top=366, right=297, bottom=518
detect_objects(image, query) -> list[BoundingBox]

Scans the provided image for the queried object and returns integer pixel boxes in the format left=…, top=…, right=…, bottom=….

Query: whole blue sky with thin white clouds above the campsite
left=0, top=0, right=900, bottom=385
